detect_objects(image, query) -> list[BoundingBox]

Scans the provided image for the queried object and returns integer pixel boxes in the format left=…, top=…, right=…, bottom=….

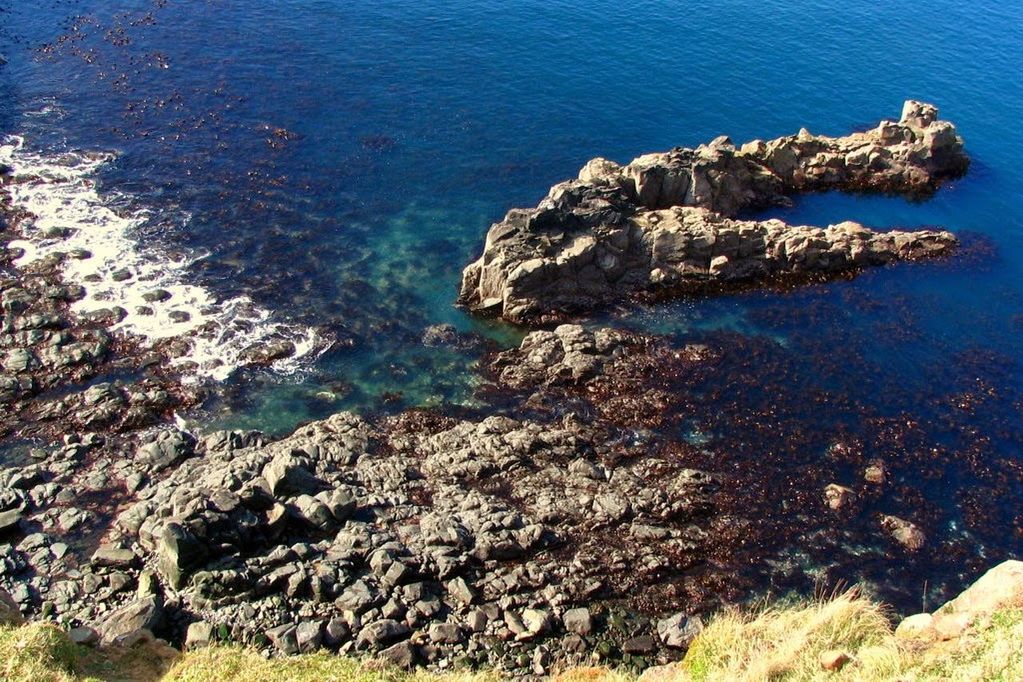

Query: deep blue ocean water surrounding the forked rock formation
left=0, top=0, right=1023, bottom=609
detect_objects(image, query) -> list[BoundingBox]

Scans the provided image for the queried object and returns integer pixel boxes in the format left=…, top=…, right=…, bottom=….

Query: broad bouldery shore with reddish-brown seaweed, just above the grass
left=6, top=325, right=1013, bottom=674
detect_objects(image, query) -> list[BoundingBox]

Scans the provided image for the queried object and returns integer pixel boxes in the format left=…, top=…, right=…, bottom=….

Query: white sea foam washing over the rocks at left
left=0, top=137, right=326, bottom=380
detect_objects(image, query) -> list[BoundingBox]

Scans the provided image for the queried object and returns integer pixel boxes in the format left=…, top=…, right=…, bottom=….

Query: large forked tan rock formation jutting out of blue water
left=458, top=101, right=969, bottom=322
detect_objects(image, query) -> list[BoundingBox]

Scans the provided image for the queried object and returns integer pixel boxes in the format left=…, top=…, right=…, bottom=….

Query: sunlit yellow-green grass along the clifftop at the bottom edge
left=0, top=593, right=1023, bottom=682
